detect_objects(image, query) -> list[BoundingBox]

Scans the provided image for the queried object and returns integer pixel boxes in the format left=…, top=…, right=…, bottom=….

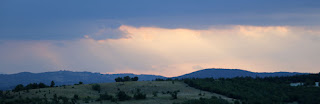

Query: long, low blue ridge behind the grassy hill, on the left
left=0, top=71, right=166, bottom=90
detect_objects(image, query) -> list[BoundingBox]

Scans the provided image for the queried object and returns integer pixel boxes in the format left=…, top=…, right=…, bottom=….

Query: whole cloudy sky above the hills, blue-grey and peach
left=0, top=0, right=320, bottom=77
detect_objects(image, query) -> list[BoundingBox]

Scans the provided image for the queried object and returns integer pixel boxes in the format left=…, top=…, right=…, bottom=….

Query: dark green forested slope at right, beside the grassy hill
left=184, top=74, right=320, bottom=104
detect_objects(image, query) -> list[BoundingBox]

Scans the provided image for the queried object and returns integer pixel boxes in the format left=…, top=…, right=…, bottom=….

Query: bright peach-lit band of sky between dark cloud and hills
left=0, top=25, right=320, bottom=76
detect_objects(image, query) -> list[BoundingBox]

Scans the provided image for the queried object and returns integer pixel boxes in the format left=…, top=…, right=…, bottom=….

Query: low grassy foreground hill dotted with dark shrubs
left=2, top=81, right=233, bottom=104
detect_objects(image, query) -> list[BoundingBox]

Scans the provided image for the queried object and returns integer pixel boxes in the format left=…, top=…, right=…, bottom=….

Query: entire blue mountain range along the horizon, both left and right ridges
left=0, top=68, right=307, bottom=90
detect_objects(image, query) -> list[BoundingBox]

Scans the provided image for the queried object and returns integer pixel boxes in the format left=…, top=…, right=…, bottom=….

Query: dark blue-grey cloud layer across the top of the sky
left=0, top=0, right=320, bottom=40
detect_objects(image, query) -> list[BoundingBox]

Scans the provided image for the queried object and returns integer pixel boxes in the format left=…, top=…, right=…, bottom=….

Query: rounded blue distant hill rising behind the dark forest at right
left=174, top=68, right=308, bottom=79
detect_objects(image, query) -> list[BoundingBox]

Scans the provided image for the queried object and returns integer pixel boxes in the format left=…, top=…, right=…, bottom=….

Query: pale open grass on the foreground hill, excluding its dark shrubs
left=5, top=81, right=233, bottom=104
